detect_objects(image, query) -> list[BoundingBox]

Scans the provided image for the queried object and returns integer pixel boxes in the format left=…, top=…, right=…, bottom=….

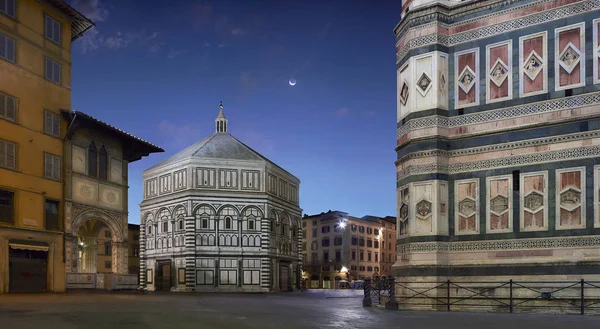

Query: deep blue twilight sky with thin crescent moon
left=70, top=0, right=401, bottom=223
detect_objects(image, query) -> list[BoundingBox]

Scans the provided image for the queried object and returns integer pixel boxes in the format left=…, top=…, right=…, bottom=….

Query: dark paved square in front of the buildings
left=0, top=291, right=600, bottom=329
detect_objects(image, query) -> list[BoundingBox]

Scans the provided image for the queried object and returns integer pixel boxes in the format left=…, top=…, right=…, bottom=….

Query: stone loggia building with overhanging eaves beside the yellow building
left=61, top=110, right=163, bottom=289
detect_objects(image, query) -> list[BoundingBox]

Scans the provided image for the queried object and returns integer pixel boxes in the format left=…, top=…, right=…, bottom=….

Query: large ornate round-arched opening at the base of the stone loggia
left=65, top=204, right=127, bottom=289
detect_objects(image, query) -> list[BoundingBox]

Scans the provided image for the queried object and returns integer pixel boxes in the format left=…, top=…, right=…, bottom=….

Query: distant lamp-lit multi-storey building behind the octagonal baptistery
left=302, top=210, right=396, bottom=289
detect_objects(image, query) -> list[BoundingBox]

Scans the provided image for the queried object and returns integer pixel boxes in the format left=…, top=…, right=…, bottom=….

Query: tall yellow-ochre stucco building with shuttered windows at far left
left=0, top=0, right=93, bottom=293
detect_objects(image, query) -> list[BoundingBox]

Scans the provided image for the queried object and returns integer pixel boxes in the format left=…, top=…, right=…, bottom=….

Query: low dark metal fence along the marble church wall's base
left=363, top=279, right=600, bottom=315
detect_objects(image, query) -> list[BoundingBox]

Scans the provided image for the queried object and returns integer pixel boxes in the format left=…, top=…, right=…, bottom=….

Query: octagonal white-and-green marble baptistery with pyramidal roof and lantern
left=140, top=105, right=302, bottom=292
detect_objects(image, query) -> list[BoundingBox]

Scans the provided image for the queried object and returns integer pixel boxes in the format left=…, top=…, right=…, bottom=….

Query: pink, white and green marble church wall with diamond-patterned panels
left=394, top=0, right=600, bottom=290
